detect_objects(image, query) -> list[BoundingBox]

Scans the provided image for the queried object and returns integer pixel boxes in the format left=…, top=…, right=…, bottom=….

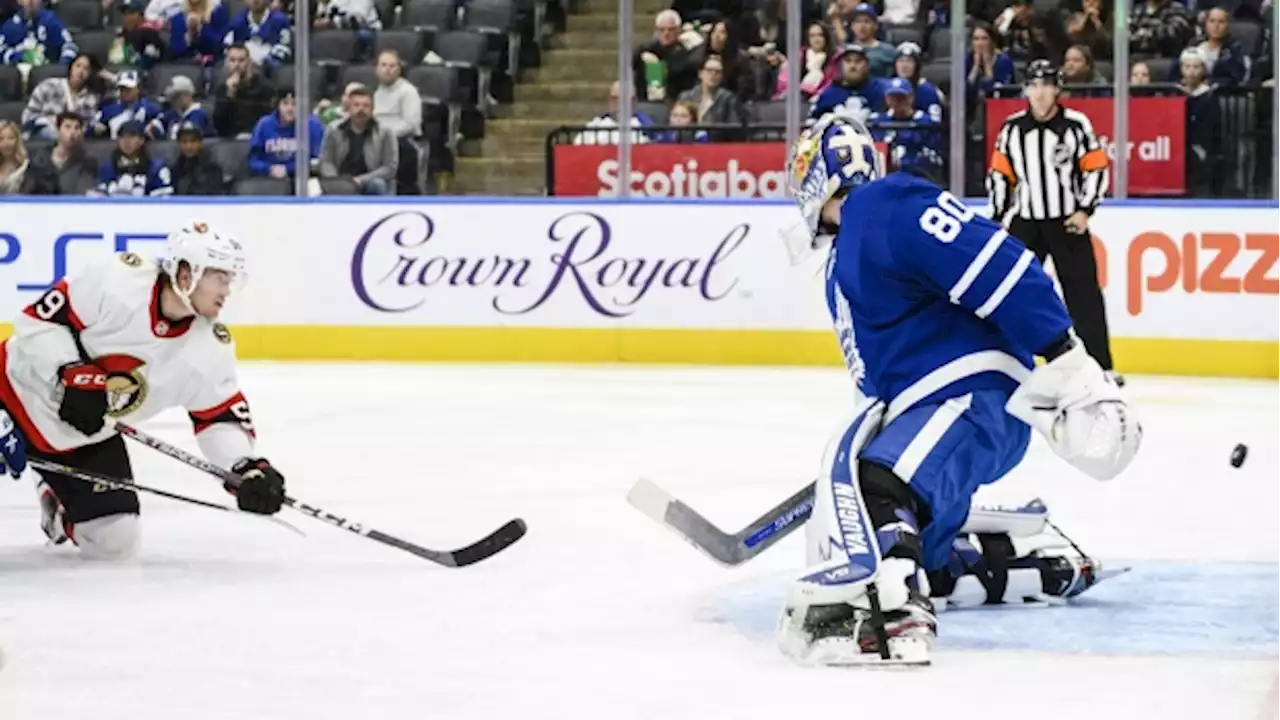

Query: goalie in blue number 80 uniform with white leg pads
left=778, top=114, right=1142, bottom=665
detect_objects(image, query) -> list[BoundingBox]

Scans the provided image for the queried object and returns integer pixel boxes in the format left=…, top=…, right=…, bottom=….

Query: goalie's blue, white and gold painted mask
left=781, top=113, right=884, bottom=265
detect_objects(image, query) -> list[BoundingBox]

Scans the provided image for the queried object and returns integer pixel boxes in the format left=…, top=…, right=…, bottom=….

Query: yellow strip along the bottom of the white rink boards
left=0, top=324, right=1280, bottom=379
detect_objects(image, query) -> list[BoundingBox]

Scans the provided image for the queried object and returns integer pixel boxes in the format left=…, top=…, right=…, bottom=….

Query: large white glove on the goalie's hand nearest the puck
left=1005, top=337, right=1142, bottom=480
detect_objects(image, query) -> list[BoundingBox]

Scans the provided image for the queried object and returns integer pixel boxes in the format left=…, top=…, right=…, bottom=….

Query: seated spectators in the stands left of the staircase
left=0, top=0, right=529, bottom=196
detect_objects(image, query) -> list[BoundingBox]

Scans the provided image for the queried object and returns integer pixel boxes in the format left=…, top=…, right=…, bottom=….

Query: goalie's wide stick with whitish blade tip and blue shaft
left=627, top=480, right=814, bottom=566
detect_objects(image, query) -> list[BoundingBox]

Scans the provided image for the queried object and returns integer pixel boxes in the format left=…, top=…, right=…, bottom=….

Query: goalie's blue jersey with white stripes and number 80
left=827, top=173, right=1071, bottom=414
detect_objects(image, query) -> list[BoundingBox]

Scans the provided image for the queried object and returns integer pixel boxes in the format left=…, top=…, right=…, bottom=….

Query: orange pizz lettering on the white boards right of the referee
left=1125, top=232, right=1280, bottom=315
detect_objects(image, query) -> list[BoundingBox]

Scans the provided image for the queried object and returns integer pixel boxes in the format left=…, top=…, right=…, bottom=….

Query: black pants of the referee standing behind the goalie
left=1009, top=218, right=1112, bottom=370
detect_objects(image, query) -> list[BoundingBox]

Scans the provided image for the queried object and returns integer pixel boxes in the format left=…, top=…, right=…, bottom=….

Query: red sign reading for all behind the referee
left=986, top=97, right=1187, bottom=196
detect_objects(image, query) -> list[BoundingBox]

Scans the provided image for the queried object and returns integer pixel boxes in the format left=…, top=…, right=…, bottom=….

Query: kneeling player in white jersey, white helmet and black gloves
left=0, top=222, right=284, bottom=557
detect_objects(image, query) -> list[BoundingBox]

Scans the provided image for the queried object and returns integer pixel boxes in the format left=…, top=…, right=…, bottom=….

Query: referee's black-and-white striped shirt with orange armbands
left=987, top=105, right=1110, bottom=224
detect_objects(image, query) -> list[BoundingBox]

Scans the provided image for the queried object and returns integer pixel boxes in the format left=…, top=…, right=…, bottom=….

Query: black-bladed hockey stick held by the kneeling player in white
left=115, top=423, right=526, bottom=568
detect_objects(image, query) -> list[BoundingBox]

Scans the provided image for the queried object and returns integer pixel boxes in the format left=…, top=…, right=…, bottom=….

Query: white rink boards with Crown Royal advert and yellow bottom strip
left=0, top=199, right=1280, bottom=378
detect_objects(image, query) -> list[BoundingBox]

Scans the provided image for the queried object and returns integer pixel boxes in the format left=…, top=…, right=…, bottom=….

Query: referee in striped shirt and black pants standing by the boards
left=987, top=60, right=1123, bottom=383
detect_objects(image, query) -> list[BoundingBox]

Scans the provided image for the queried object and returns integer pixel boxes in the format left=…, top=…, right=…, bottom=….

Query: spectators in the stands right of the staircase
left=575, top=0, right=1276, bottom=193
